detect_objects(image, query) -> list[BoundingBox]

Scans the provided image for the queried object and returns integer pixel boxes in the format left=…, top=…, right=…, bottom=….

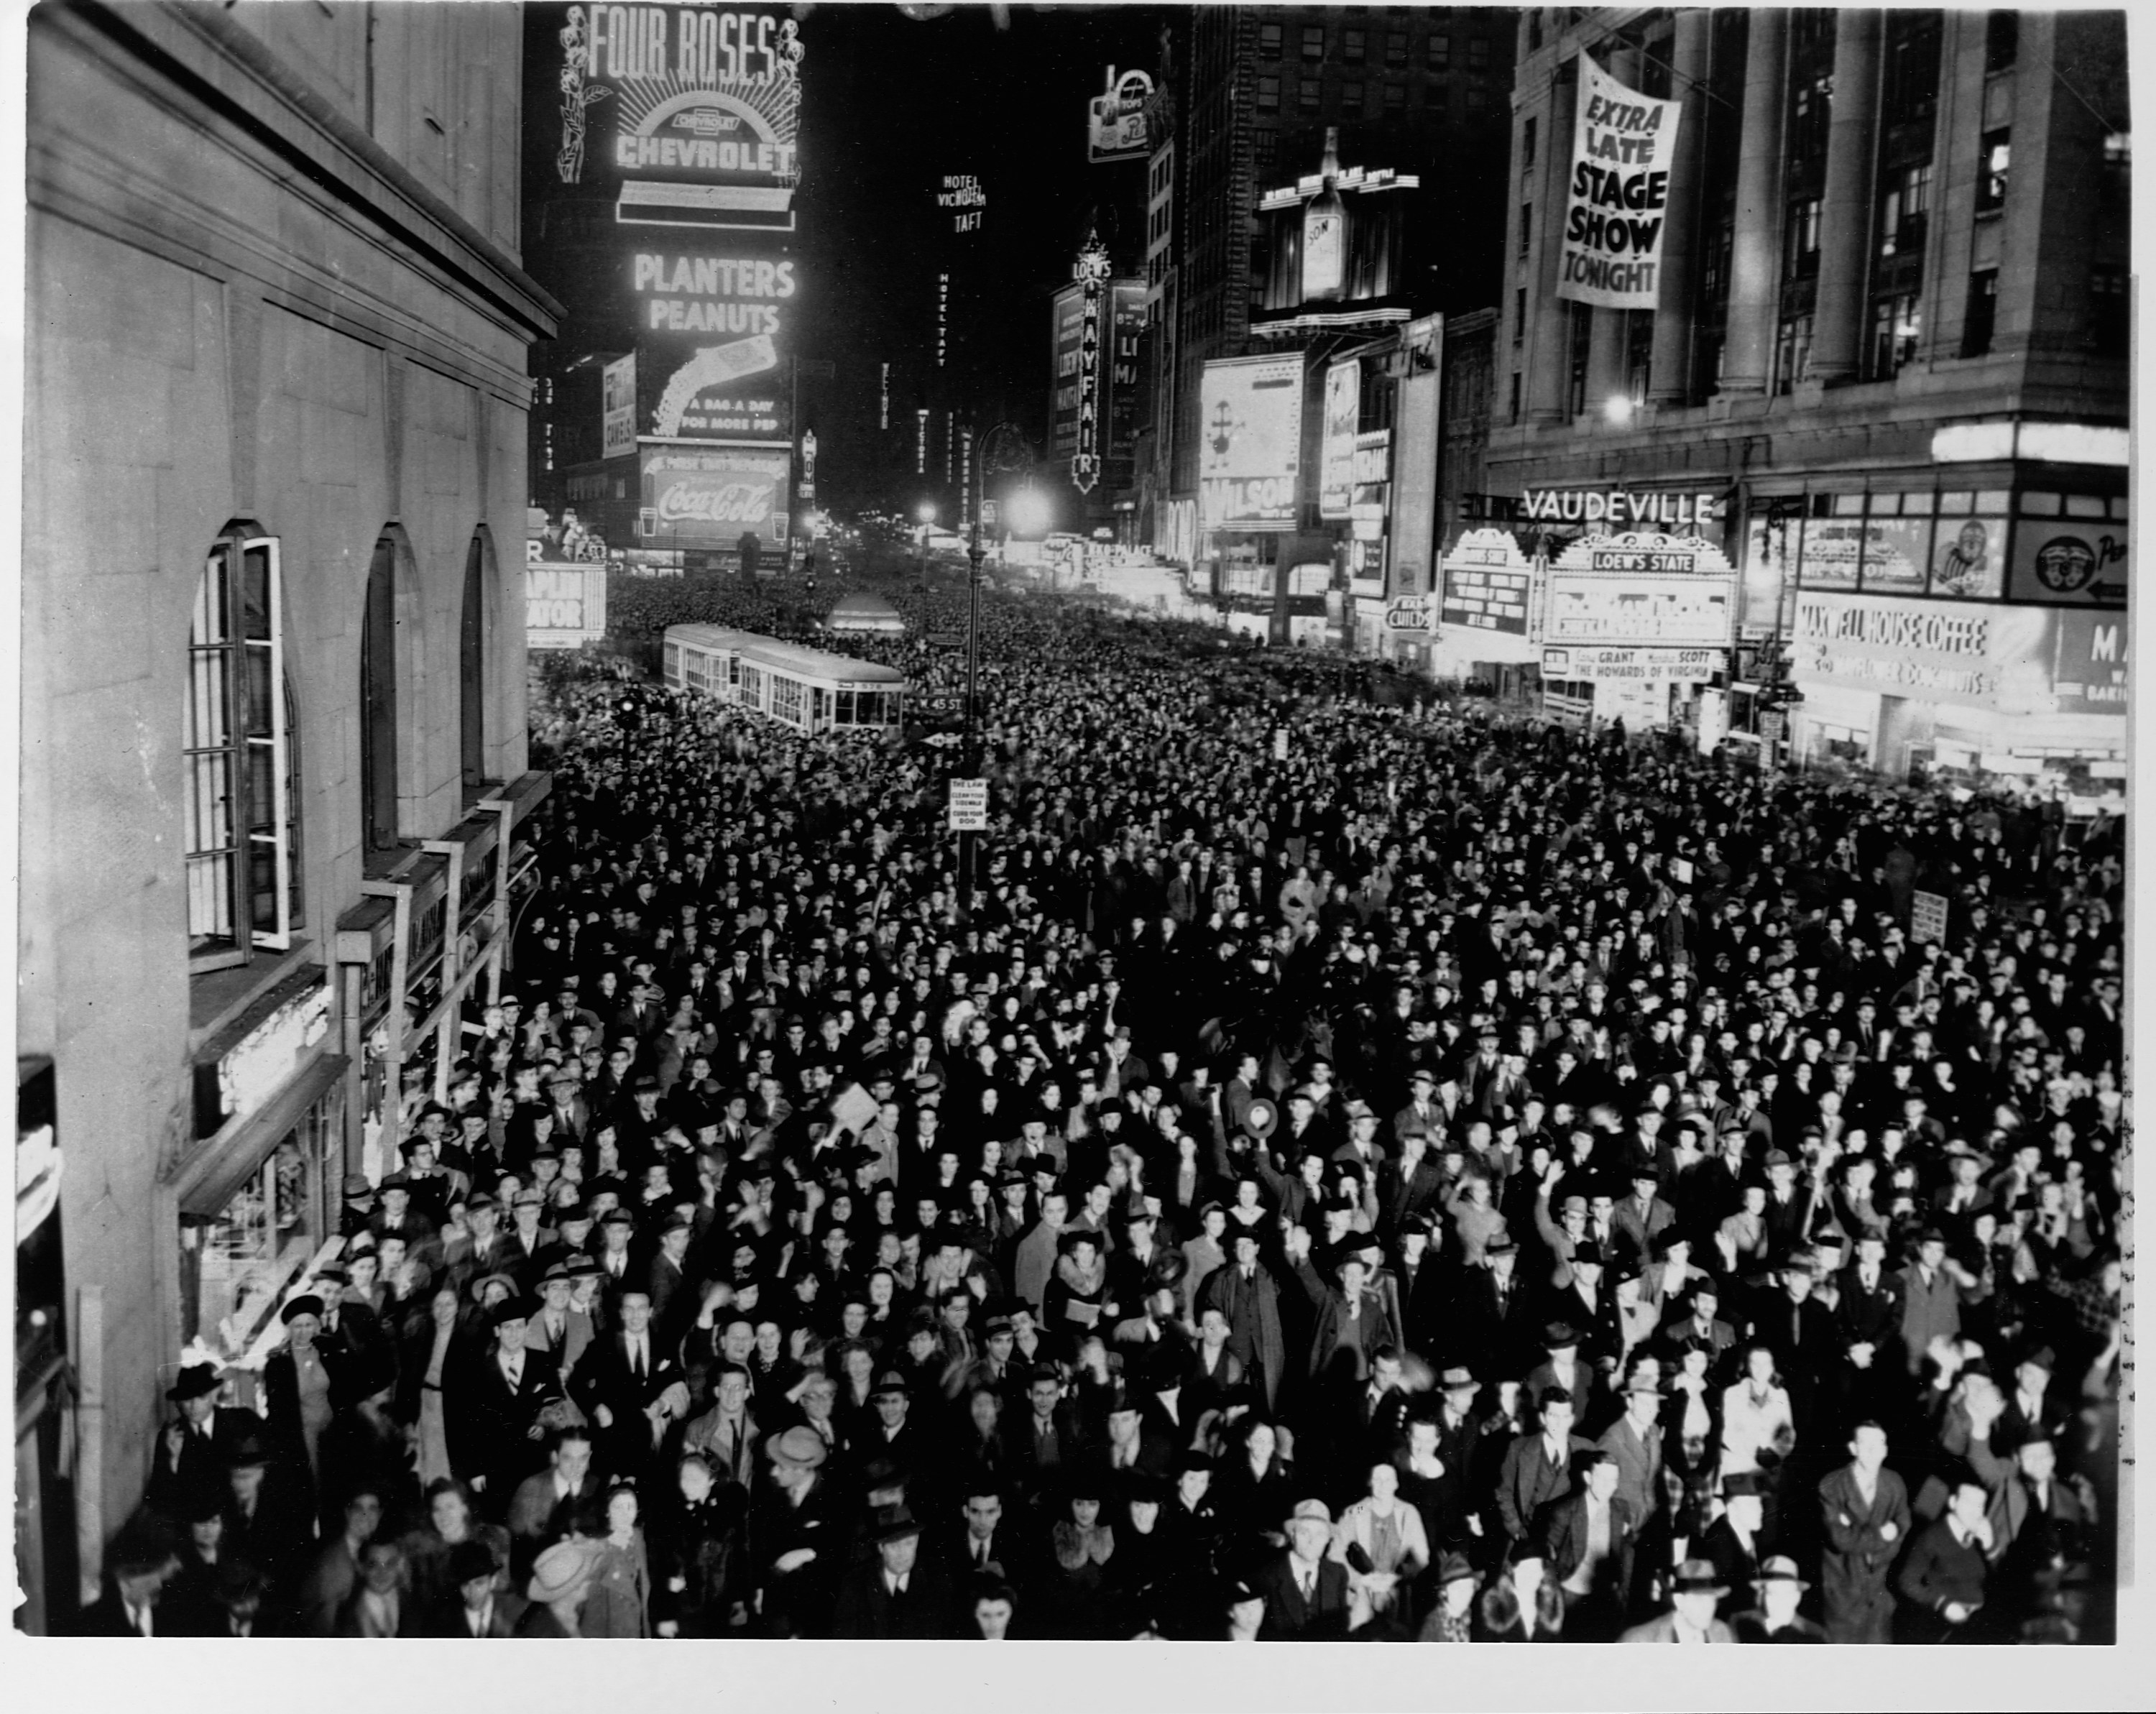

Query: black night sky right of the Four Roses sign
left=800, top=4, right=1166, bottom=455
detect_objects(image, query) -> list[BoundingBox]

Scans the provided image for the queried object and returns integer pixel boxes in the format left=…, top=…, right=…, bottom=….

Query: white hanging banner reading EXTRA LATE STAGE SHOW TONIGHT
left=1557, top=47, right=1684, bottom=310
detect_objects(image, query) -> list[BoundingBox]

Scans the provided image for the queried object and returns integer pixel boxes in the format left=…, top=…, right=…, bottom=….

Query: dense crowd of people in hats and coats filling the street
left=86, top=595, right=2130, bottom=1643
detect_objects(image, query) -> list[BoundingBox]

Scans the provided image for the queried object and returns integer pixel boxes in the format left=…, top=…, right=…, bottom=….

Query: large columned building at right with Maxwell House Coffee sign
left=1483, top=6, right=2132, bottom=776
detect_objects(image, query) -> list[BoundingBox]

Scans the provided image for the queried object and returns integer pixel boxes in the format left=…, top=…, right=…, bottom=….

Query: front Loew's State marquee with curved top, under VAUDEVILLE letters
left=1542, top=535, right=1736, bottom=649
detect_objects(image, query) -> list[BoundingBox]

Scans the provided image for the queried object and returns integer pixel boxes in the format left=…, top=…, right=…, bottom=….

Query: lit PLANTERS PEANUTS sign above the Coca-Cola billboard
left=630, top=248, right=796, bottom=442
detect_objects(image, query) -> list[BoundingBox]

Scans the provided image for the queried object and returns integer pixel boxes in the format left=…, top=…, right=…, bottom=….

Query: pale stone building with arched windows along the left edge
left=15, top=0, right=558, bottom=1630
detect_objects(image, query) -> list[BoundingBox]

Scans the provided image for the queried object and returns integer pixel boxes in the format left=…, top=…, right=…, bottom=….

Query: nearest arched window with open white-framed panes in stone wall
left=181, top=526, right=302, bottom=970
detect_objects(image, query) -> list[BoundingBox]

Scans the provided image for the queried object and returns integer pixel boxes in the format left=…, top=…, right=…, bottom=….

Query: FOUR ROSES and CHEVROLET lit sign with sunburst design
left=554, top=4, right=804, bottom=233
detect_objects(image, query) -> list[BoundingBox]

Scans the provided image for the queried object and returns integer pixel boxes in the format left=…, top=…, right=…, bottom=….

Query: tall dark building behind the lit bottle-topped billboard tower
left=1151, top=6, right=1518, bottom=558
